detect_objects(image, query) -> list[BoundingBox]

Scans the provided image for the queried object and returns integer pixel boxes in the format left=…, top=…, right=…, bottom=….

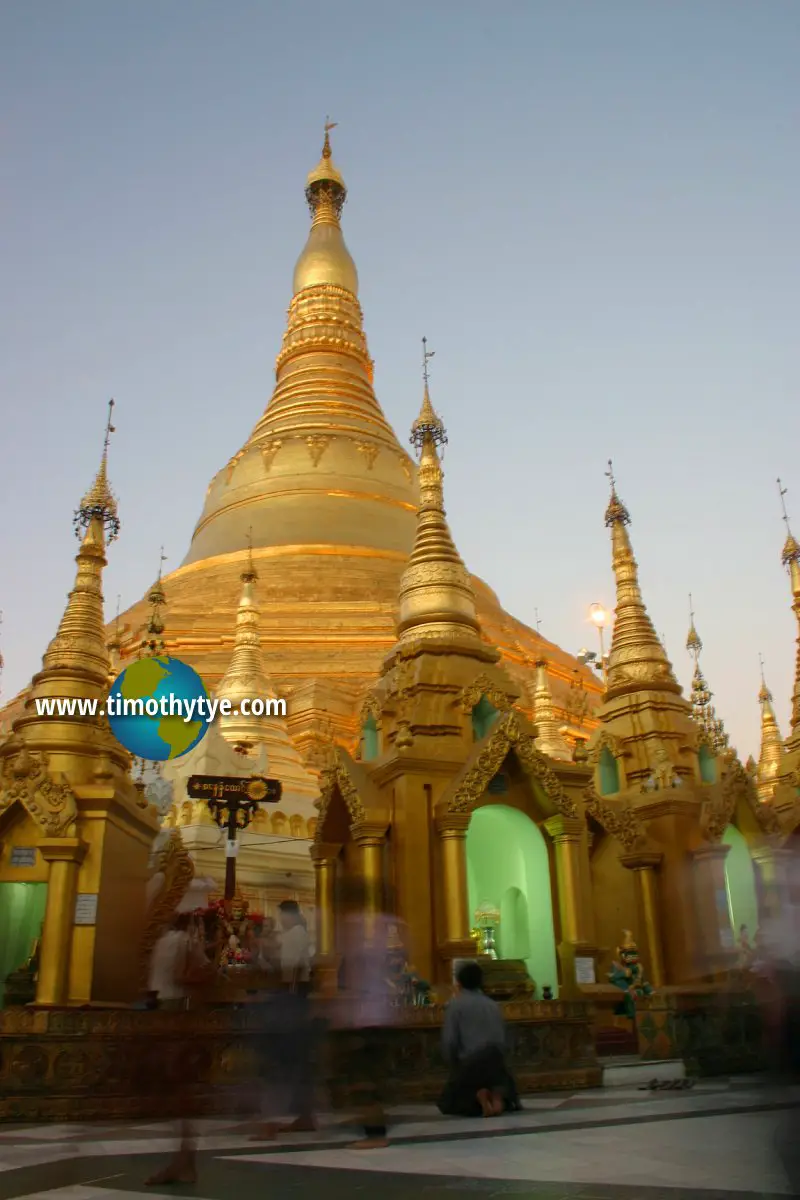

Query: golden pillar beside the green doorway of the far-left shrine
left=36, top=838, right=88, bottom=1006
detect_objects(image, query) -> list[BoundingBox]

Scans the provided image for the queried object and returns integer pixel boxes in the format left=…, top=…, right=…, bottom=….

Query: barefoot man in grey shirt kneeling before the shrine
left=439, top=962, right=521, bottom=1117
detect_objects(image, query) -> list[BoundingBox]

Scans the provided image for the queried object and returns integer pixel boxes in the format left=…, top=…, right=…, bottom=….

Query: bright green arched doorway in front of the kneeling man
left=467, top=804, right=558, bottom=996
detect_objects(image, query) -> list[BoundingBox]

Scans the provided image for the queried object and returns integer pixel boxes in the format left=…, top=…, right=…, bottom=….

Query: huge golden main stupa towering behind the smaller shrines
left=97, top=125, right=600, bottom=772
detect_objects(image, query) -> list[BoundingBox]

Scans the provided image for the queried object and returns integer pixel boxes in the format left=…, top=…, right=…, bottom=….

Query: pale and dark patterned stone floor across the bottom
left=0, top=1076, right=800, bottom=1200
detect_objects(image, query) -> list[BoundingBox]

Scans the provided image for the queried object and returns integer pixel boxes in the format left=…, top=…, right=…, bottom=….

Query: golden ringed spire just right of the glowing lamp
left=606, top=460, right=680, bottom=700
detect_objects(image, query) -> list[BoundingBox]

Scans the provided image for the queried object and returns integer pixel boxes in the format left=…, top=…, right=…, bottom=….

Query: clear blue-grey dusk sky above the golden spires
left=0, top=0, right=800, bottom=756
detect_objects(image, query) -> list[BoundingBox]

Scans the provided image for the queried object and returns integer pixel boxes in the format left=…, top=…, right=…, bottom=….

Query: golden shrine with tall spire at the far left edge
left=0, top=401, right=158, bottom=1006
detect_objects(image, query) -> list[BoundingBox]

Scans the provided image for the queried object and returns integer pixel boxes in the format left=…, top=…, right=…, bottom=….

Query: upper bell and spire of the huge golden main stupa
left=184, top=121, right=417, bottom=565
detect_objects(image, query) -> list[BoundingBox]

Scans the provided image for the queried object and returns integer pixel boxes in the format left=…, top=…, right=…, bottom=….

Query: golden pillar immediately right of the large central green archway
left=536, top=815, right=597, bottom=997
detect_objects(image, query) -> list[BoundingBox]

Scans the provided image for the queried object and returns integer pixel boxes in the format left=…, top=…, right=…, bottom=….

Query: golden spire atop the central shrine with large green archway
left=397, top=337, right=479, bottom=641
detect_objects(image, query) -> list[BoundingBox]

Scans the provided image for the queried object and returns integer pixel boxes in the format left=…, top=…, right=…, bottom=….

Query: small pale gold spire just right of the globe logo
left=216, top=534, right=273, bottom=749
